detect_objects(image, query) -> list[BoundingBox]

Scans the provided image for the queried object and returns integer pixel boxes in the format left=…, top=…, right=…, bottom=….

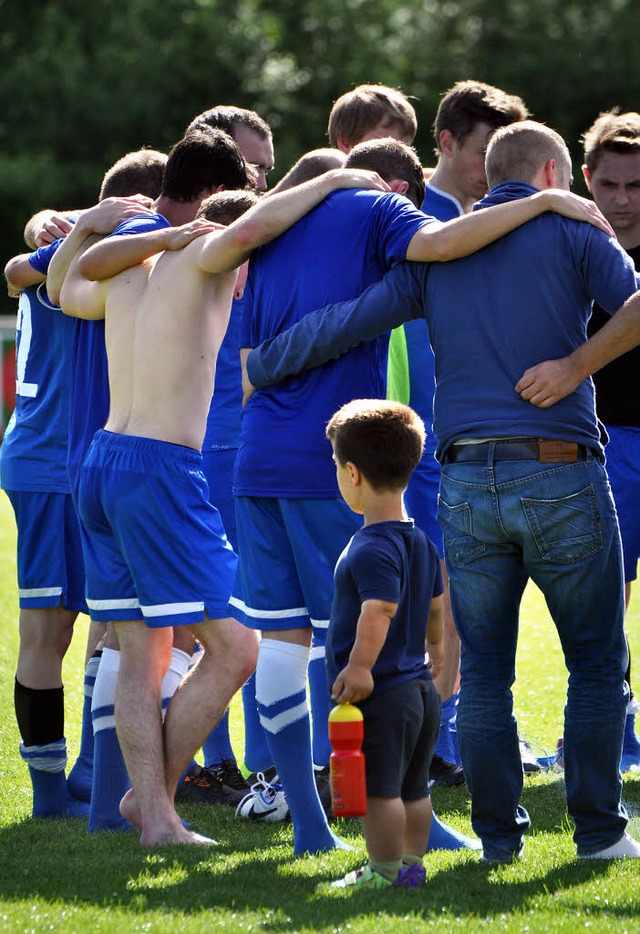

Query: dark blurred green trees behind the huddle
left=0, top=0, right=640, bottom=311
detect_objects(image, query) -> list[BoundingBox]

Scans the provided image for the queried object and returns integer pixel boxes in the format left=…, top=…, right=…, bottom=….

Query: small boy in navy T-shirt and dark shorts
left=327, top=399, right=442, bottom=888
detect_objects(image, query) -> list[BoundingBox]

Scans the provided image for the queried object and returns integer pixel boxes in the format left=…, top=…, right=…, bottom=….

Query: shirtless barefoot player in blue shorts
left=53, top=169, right=387, bottom=846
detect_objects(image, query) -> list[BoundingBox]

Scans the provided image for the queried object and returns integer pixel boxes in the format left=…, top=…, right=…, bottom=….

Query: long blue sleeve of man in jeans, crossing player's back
left=247, top=263, right=428, bottom=389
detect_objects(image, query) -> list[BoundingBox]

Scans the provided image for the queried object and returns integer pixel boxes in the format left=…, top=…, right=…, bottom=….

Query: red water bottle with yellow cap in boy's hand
left=329, top=704, right=367, bottom=817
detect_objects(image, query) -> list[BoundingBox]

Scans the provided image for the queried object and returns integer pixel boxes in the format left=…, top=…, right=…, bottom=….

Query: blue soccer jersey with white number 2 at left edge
left=0, top=240, right=73, bottom=493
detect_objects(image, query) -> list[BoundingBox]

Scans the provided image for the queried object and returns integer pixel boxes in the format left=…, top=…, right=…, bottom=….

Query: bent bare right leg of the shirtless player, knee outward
left=164, top=618, right=258, bottom=801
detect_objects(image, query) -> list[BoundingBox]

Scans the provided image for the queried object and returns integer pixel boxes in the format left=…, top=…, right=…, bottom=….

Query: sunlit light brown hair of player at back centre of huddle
left=327, top=84, right=418, bottom=146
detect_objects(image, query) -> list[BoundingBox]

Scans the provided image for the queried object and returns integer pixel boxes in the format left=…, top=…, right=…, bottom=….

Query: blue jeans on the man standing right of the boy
left=438, top=445, right=628, bottom=859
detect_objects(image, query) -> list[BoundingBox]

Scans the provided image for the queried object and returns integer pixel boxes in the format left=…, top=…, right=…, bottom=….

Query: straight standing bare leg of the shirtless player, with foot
left=116, top=621, right=209, bottom=846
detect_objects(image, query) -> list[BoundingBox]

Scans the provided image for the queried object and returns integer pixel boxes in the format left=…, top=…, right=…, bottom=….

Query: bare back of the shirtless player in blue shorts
left=105, top=241, right=237, bottom=450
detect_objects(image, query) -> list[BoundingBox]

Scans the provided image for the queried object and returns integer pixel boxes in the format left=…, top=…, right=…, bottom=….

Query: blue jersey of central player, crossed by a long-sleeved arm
left=235, top=190, right=429, bottom=498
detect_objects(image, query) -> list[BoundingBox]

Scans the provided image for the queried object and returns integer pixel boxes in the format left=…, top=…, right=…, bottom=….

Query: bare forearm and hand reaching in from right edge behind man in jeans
left=516, top=291, right=640, bottom=409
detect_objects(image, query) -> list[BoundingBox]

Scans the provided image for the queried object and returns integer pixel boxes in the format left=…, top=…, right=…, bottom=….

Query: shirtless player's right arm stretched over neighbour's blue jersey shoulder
left=198, top=169, right=390, bottom=274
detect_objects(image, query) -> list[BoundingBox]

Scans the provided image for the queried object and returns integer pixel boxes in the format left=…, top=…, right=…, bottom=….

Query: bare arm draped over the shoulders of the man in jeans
left=406, top=189, right=614, bottom=262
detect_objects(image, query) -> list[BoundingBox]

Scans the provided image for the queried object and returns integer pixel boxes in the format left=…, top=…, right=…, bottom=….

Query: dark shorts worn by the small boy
left=358, top=678, right=440, bottom=801
